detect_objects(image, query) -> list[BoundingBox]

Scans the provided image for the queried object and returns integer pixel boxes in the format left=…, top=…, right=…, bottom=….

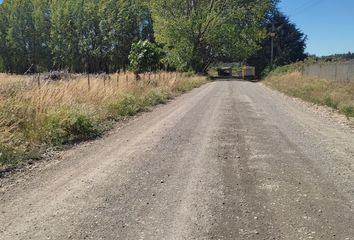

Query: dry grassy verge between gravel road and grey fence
left=264, top=70, right=354, bottom=119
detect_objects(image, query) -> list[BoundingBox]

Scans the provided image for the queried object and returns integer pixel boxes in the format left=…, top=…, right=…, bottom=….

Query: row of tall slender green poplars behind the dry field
left=0, top=0, right=153, bottom=73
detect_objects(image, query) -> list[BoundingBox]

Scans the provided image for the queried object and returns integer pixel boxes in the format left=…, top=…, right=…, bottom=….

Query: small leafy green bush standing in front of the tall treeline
left=129, top=40, right=162, bottom=73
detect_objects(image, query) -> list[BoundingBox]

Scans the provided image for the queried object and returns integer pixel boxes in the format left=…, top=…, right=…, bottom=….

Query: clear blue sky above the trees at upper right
left=279, top=0, right=354, bottom=56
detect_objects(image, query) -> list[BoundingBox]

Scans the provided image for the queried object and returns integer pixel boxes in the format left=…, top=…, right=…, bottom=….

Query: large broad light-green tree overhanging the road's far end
left=151, top=0, right=272, bottom=72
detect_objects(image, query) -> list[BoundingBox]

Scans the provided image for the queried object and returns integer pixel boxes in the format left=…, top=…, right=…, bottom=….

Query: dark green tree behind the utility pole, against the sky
left=247, top=9, right=307, bottom=75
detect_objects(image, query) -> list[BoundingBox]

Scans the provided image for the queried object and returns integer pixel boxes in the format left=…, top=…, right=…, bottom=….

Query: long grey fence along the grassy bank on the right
left=303, top=62, right=354, bottom=82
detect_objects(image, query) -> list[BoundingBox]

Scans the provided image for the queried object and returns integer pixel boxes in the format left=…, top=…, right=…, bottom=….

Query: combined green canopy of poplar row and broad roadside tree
left=0, top=0, right=274, bottom=73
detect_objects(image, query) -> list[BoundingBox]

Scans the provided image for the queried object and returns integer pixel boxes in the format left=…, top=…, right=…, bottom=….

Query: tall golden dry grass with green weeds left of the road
left=0, top=73, right=207, bottom=173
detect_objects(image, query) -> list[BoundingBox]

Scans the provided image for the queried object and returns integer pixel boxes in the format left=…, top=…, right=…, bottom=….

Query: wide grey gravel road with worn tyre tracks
left=0, top=80, right=354, bottom=240
